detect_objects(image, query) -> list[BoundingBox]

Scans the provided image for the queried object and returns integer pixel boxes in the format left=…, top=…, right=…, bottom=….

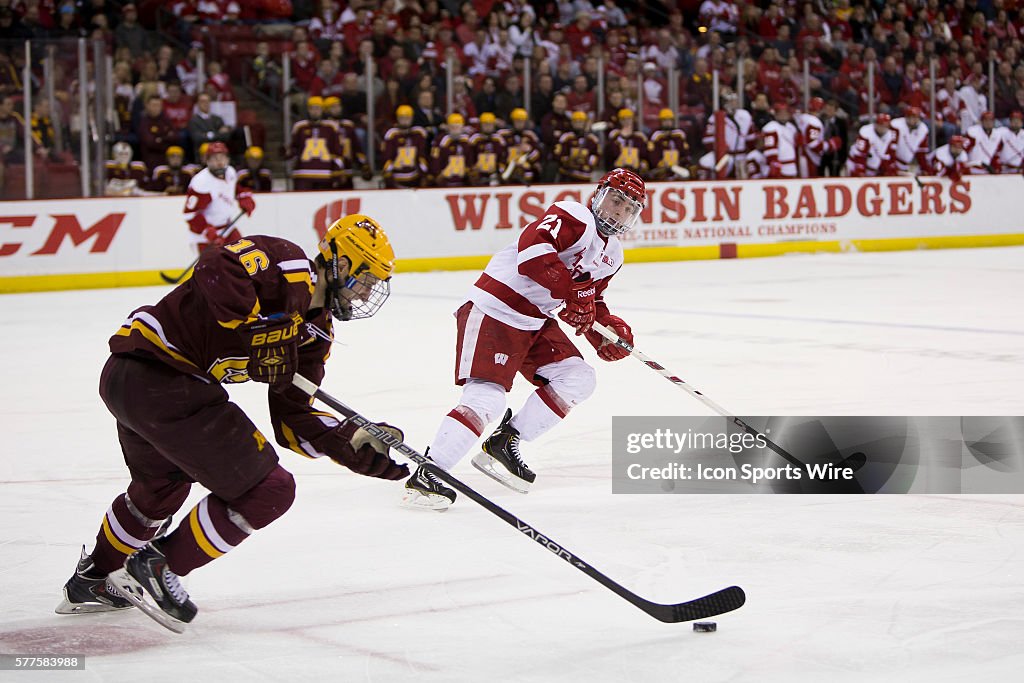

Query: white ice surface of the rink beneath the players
left=0, top=248, right=1024, bottom=683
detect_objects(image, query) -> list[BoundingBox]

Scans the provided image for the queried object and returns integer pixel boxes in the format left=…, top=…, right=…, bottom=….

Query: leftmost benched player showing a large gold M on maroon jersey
left=289, top=96, right=342, bottom=190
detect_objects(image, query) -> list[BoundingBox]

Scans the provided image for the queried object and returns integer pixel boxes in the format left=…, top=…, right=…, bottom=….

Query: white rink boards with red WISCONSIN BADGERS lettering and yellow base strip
left=0, top=175, right=1024, bottom=292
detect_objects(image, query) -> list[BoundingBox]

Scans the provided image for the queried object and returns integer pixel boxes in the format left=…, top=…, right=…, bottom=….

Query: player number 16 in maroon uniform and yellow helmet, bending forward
left=56, top=215, right=409, bottom=633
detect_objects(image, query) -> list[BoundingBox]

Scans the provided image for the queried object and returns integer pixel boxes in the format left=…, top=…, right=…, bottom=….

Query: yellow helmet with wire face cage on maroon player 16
left=318, top=214, right=394, bottom=321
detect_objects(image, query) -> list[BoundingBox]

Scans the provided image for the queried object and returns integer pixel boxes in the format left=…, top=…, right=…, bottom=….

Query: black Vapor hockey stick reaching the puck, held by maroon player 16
left=292, top=375, right=746, bottom=624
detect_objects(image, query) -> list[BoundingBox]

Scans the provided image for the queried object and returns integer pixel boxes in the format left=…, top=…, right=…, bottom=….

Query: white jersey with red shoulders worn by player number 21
left=469, top=202, right=623, bottom=330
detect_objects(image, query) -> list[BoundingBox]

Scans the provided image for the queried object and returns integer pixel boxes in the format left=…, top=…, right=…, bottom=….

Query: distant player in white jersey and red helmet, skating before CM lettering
left=185, top=142, right=256, bottom=251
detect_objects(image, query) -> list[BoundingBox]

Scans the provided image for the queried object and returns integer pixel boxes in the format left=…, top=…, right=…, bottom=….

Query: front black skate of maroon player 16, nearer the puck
left=111, top=542, right=199, bottom=633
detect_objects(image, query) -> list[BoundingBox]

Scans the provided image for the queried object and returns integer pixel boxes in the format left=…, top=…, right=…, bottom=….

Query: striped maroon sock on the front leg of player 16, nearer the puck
left=160, top=494, right=255, bottom=577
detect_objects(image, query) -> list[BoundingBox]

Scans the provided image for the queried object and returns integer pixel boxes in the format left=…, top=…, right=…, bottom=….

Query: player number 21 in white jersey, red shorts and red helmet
left=402, top=168, right=646, bottom=510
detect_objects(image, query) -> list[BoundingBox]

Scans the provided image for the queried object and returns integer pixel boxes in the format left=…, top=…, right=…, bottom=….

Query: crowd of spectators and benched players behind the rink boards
left=0, top=0, right=1024, bottom=197
